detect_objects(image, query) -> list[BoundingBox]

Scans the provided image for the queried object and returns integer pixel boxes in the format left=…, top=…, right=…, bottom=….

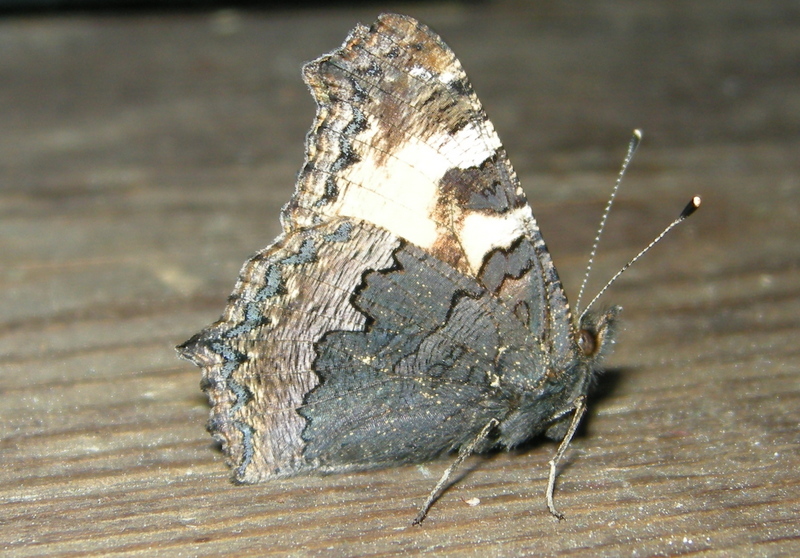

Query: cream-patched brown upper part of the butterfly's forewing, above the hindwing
left=284, top=15, right=536, bottom=275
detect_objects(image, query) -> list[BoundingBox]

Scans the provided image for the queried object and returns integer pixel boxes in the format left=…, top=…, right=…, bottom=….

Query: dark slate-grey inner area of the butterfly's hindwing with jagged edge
left=300, top=243, right=568, bottom=470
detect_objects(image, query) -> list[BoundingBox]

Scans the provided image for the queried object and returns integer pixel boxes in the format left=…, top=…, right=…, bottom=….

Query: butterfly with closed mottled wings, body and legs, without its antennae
left=178, top=14, right=619, bottom=523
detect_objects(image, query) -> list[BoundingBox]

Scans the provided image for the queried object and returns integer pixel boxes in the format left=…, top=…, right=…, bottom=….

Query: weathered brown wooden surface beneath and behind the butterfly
left=0, top=1, right=800, bottom=556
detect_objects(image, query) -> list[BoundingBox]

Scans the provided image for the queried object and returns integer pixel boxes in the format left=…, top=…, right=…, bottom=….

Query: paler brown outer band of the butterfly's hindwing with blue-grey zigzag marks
left=184, top=219, right=399, bottom=482
